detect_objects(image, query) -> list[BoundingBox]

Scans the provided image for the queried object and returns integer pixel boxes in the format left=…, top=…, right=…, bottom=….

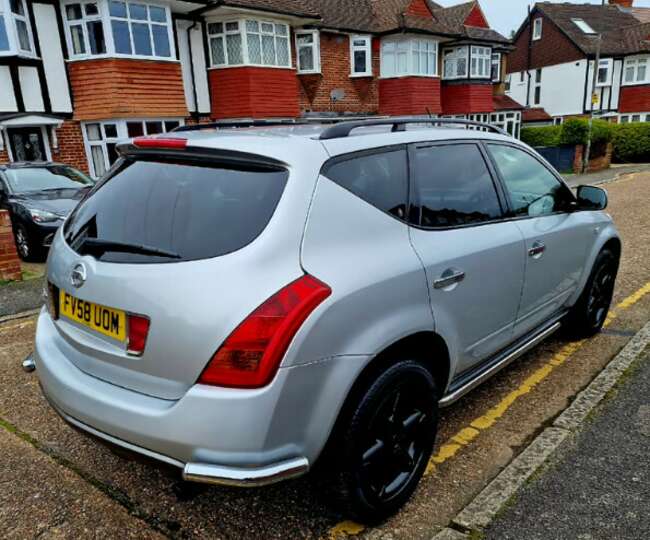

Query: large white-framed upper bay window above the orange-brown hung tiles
left=63, top=0, right=175, bottom=59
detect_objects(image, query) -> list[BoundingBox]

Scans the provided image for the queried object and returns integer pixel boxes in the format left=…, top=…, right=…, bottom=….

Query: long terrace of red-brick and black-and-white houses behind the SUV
left=0, top=0, right=522, bottom=177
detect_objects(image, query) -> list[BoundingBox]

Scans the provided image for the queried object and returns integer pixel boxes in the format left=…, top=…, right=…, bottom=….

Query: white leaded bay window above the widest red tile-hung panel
left=208, top=19, right=291, bottom=68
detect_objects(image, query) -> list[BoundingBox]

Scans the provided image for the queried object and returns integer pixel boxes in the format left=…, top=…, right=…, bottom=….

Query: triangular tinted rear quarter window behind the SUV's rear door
left=323, top=150, right=408, bottom=219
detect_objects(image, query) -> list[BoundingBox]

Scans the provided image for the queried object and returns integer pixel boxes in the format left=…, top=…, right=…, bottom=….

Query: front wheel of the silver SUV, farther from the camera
left=565, top=248, right=619, bottom=339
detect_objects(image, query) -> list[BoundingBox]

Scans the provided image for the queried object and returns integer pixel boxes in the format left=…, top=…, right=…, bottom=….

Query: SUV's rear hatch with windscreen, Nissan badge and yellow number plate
left=48, top=144, right=306, bottom=400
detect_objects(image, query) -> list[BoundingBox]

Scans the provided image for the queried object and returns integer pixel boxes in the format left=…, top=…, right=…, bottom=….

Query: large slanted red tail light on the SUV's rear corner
left=198, top=275, right=332, bottom=388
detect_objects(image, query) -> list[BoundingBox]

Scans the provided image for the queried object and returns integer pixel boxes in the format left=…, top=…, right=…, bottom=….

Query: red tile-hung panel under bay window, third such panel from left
left=379, top=77, right=442, bottom=115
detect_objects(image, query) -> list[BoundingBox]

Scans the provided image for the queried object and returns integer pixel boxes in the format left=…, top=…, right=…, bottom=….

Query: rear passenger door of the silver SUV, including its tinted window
left=409, top=141, right=525, bottom=373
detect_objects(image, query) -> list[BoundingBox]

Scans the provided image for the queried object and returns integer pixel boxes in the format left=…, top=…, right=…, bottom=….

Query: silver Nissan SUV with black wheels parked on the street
left=34, top=118, right=621, bottom=522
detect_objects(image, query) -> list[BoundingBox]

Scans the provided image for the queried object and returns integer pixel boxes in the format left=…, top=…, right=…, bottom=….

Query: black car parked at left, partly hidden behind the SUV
left=0, top=162, right=94, bottom=260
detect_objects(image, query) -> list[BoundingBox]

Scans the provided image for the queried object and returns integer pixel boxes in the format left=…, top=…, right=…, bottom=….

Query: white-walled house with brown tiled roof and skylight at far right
left=506, top=0, right=650, bottom=125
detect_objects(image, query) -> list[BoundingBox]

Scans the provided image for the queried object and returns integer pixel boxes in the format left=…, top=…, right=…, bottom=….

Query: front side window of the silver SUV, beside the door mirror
left=488, top=144, right=573, bottom=216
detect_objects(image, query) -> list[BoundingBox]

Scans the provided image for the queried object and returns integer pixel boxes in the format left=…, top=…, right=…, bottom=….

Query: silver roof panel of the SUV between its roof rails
left=178, top=124, right=519, bottom=163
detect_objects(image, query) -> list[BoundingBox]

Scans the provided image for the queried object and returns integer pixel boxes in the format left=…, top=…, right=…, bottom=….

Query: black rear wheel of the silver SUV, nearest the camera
left=333, top=360, right=438, bottom=524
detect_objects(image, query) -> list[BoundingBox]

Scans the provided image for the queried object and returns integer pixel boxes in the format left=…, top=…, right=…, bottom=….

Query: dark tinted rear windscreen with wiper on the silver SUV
left=64, top=160, right=289, bottom=263
